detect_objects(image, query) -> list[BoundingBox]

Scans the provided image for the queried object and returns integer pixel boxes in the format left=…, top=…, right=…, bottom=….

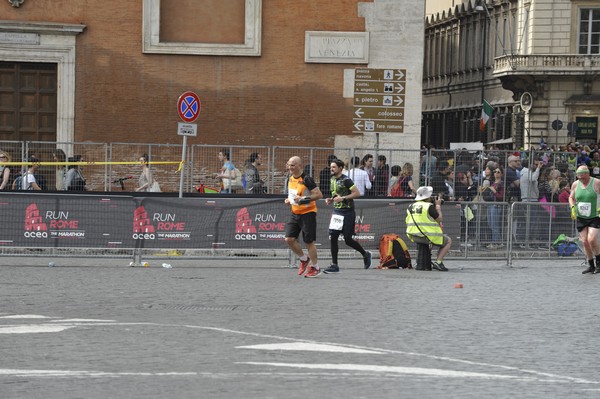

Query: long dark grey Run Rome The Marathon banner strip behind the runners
left=0, top=193, right=460, bottom=249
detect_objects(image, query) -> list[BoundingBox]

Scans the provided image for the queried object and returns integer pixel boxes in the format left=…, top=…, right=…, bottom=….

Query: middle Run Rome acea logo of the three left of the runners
left=133, top=205, right=192, bottom=241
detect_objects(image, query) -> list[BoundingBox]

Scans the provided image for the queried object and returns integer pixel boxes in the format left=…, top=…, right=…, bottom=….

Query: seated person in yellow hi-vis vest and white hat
left=406, top=186, right=452, bottom=272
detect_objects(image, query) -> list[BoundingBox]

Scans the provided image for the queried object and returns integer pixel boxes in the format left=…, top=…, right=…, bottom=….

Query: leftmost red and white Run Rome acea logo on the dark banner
left=23, top=203, right=85, bottom=239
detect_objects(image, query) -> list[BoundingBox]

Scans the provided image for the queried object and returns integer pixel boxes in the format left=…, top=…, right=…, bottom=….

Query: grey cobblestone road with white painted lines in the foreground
left=0, top=257, right=600, bottom=399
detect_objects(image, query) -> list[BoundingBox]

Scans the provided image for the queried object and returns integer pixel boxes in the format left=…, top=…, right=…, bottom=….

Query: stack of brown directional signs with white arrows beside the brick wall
left=352, top=68, right=406, bottom=133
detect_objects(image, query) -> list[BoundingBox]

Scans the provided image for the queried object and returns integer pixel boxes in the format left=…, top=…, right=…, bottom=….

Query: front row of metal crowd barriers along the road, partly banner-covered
left=0, top=192, right=578, bottom=265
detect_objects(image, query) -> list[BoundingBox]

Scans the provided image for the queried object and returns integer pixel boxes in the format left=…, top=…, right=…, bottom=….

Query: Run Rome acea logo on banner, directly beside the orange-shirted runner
left=235, top=208, right=285, bottom=241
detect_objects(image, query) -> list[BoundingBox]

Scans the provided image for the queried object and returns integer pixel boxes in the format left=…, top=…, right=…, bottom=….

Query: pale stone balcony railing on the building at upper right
left=493, top=54, right=600, bottom=77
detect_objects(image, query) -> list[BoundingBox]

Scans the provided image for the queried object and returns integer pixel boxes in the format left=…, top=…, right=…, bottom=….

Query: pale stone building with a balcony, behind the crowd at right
left=422, top=0, right=600, bottom=148
